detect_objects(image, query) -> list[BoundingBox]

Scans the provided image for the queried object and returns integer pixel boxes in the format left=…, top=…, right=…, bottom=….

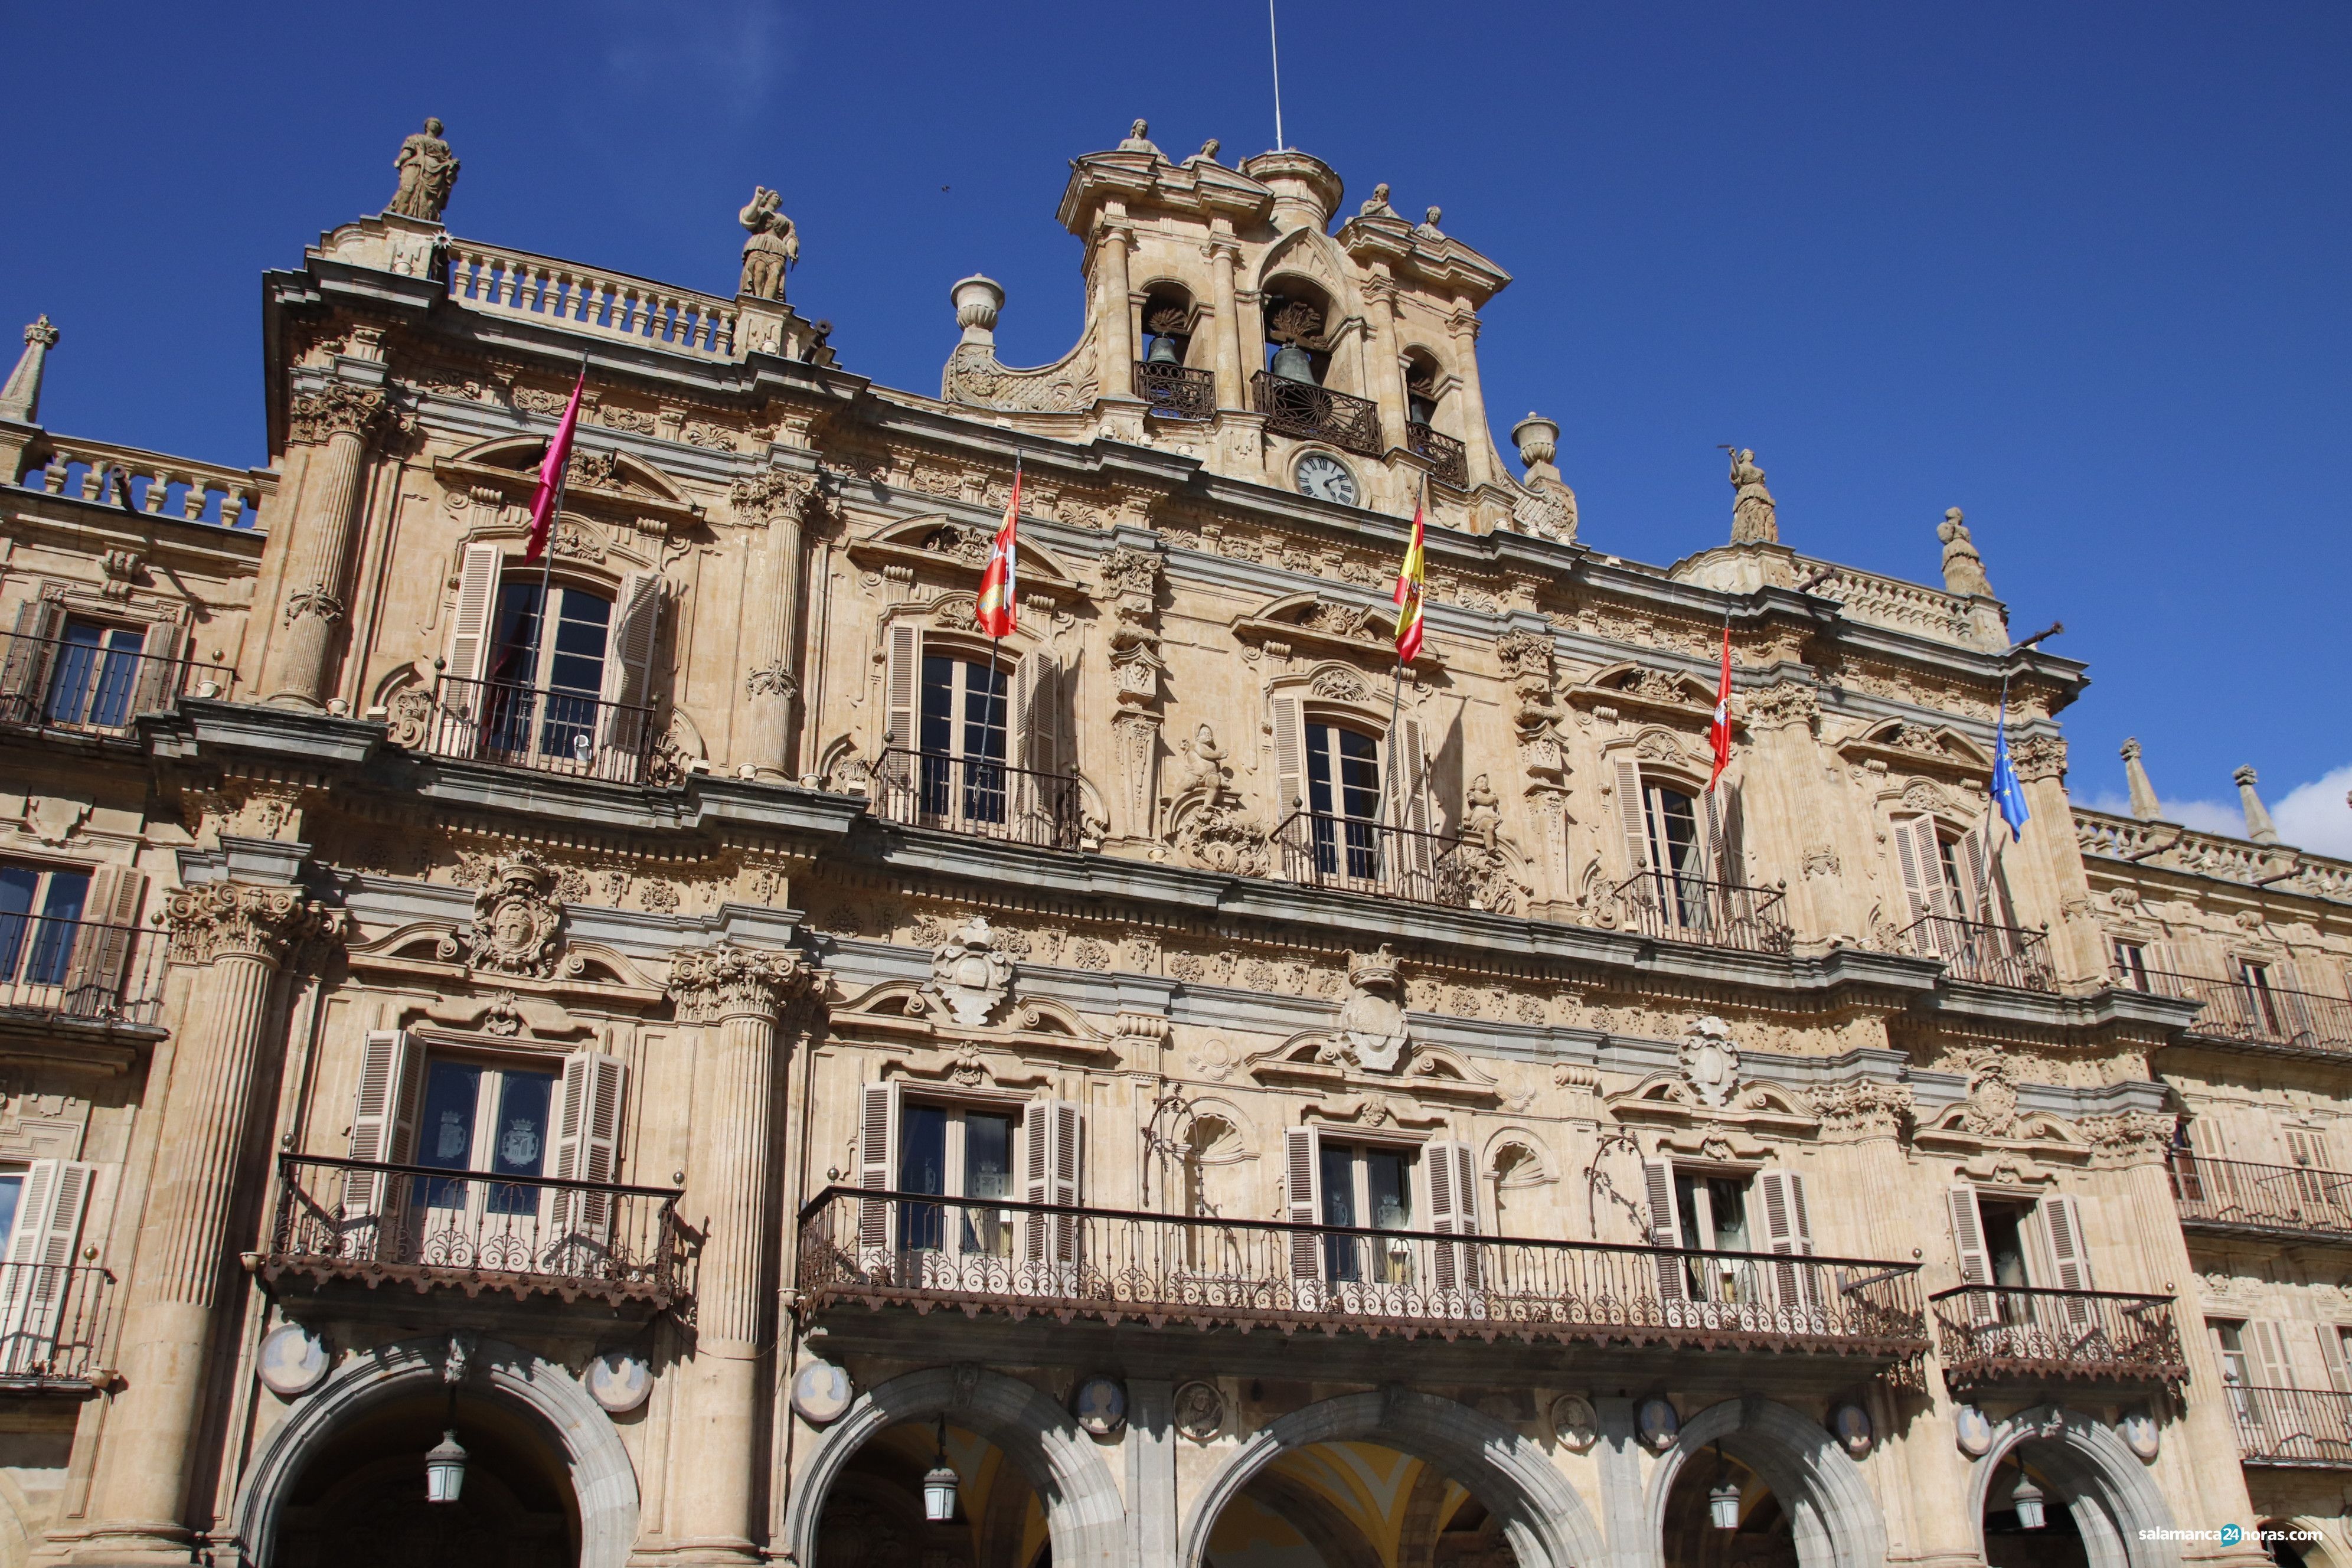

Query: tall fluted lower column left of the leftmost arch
left=75, top=881, right=332, bottom=1561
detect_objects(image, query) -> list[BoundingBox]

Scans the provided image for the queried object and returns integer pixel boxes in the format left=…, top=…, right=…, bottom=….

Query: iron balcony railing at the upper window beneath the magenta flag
left=390, top=675, right=675, bottom=783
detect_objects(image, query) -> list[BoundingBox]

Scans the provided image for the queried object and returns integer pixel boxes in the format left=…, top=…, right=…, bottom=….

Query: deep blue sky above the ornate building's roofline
left=0, top=0, right=2352, bottom=853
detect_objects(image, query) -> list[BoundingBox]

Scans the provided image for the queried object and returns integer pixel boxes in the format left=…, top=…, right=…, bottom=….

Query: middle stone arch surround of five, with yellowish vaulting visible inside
left=1185, top=1387, right=1606, bottom=1568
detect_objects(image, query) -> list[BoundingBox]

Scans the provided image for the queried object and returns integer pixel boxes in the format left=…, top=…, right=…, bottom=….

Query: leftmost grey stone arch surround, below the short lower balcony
left=233, top=1335, right=638, bottom=1568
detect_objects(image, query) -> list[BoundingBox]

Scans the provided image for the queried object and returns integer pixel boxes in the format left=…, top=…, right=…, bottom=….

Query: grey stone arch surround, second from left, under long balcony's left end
left=783, top=1366, right=1126, bottom=1568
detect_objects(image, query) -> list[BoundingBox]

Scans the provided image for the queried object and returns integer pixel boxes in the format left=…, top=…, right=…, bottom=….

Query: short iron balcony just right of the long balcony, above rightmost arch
left=1929, top=1286, right=2190, bottom=1396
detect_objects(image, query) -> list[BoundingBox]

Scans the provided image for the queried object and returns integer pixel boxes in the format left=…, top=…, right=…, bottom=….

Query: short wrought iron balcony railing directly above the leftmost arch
left=261, top=1154, right=680, bottom=1309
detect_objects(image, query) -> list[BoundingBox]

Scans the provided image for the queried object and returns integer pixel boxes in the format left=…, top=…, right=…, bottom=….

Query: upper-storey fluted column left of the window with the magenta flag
left=263, top=381, right=386, bottom=708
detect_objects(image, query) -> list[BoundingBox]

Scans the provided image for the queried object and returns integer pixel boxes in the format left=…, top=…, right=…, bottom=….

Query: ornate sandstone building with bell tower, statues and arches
left=0, top=125, right=2352, bottom=1568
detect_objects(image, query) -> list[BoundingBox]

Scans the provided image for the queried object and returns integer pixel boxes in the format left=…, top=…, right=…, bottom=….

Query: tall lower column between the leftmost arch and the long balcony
left=670, top=945, right=809, bottom=1563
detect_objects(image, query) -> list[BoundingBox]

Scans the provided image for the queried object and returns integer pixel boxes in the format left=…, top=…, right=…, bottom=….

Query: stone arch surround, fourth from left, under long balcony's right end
left=1642, top=1394, right=1886, bottom=1568
